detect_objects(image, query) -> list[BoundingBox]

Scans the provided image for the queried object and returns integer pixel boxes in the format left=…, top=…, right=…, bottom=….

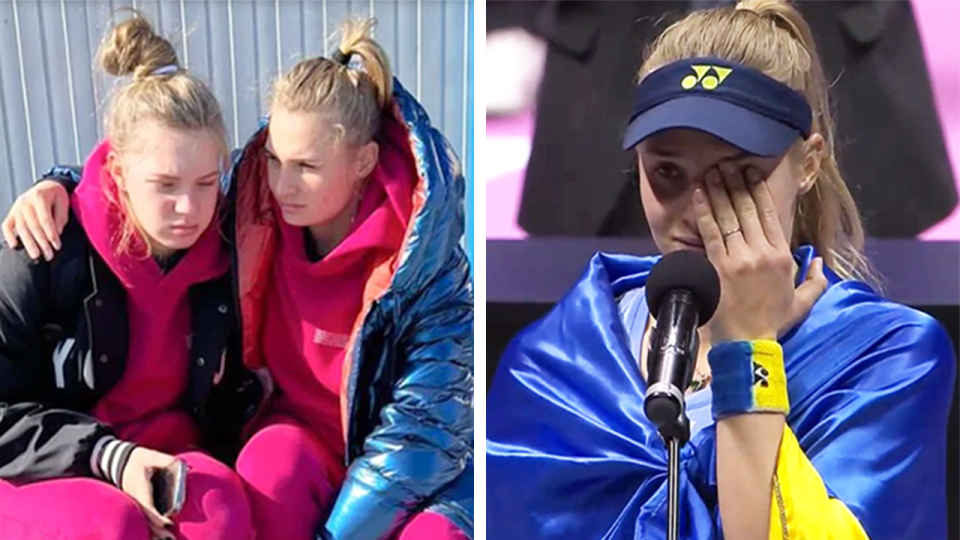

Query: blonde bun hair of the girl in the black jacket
left=97, top=10, right=228, bottom=253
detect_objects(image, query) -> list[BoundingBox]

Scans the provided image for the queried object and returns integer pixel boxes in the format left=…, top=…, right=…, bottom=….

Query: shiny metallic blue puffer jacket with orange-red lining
left=229, top=81, right=473, bottom=540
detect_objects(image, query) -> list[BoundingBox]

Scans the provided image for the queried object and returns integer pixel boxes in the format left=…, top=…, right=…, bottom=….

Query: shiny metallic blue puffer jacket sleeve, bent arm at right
left=326, top=250, right=473, bottom=540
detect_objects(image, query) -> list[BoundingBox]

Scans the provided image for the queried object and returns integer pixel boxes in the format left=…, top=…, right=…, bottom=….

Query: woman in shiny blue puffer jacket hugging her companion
left=4, top=13, right=473, bottom=540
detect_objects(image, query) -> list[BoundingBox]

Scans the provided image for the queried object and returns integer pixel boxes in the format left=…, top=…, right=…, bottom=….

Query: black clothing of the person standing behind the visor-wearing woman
left=496, top=1, right=957, bottom=237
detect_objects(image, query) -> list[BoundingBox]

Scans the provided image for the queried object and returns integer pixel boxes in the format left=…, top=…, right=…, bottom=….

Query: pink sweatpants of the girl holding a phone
left=0, top=452, right=254, bottom=540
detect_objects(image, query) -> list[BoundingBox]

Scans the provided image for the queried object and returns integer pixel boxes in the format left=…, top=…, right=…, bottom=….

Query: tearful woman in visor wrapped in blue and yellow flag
left=487, top=0, right=955, bottom=540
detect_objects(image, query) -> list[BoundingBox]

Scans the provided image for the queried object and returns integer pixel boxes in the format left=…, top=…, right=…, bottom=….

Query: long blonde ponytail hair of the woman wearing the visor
left=639, top=0, right=880, bottom=287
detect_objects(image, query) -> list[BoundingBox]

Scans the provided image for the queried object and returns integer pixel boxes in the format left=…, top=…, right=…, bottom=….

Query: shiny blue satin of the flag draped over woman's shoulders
left=487, top=246, right=955, bottom=540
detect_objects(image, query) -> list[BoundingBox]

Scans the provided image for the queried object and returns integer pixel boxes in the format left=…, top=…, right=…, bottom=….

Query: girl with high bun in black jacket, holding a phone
left=0, top=16, right=259, bottom=540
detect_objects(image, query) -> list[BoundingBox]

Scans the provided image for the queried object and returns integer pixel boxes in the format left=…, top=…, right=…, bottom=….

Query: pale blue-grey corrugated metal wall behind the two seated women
left=0, top=0, right=473, bottom=224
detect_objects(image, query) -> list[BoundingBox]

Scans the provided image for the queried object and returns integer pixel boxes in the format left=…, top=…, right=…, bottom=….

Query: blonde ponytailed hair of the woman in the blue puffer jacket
left=270, top=19, right=393, bottom=145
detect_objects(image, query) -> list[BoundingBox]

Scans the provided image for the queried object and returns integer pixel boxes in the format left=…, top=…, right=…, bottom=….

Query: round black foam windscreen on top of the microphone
left=646, top=250, right=720, bottom=325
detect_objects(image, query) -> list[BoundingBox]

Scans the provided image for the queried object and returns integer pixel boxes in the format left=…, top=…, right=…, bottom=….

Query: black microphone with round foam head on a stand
left=643, top=250, right=720, bottom=442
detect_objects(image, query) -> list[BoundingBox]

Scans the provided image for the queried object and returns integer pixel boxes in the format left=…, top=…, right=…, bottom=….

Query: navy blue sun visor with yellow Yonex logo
left=623, top=58, right=812, bottom=157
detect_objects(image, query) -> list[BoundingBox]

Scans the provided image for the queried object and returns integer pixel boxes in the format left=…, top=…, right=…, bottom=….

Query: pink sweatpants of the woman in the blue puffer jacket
left=237, top=416, right=467, bottom=540
